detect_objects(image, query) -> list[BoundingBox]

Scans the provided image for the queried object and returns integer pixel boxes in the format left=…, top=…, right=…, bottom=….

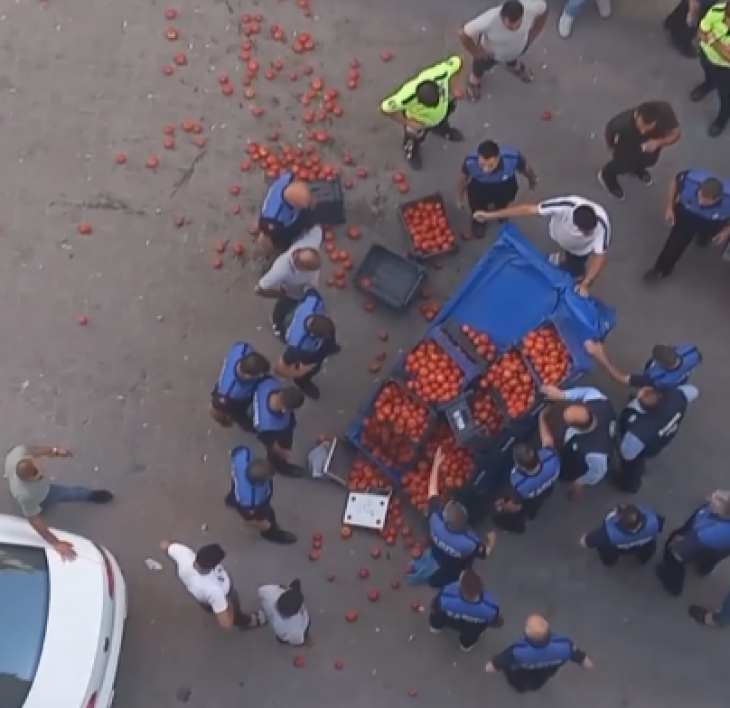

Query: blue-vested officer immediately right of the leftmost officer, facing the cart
left=253, top=376, right=304, bottom=477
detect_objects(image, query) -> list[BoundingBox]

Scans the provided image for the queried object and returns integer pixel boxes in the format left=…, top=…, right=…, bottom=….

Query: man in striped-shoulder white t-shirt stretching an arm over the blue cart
left=474, top=196, right=611, bottom=297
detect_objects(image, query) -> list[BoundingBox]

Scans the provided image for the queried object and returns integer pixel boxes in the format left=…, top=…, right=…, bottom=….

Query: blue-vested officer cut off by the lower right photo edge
left=656, top=490, right=730, bottom=597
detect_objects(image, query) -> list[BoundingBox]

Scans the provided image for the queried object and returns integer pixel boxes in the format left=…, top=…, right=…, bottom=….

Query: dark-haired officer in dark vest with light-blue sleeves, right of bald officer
left=611, top=384, right=700, bottom=493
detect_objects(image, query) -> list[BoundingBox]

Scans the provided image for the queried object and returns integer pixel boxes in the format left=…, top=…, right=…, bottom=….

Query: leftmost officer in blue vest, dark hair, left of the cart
left=210, top=342, right=271, bottom=432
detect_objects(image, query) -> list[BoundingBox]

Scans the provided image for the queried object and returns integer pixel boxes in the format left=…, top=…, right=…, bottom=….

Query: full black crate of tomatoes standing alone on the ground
left=398, top=192, right=458, bottom=260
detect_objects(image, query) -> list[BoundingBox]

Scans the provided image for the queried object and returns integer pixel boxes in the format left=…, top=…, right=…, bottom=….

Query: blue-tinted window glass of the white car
left=0, top=543, right=50, bottom=708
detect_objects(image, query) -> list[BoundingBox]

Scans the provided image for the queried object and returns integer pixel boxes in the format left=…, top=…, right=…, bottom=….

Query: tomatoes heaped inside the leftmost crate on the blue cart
left=361, top=382, right=430, bottom=469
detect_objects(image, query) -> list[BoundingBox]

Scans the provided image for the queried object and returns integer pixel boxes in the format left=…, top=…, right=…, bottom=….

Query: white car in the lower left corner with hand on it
left=0, top=514, right=127, bottom=708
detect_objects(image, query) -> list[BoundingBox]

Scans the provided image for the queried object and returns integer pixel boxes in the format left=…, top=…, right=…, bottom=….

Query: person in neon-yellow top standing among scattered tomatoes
left=380, top=56, right=464, bottom=170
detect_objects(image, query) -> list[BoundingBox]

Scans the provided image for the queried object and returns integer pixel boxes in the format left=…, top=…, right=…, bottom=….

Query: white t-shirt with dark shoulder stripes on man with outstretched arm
left=538, top=196, right=611, bottom=256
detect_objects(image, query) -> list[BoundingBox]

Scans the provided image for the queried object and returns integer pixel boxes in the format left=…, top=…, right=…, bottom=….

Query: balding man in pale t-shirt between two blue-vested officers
left=256, top=226, right=323, bottom=338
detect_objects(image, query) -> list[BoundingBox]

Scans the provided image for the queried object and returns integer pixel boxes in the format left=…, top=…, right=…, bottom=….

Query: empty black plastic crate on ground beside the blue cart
left=355, top=243, right=426, bottom=310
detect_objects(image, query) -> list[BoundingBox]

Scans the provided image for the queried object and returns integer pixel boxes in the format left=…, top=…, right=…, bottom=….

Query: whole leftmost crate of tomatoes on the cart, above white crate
left=349, top=379, right=436, bottom=481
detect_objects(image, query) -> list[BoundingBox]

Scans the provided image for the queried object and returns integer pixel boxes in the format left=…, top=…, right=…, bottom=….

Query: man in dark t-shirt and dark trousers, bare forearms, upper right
left=598, top=101, right=682, bottom=201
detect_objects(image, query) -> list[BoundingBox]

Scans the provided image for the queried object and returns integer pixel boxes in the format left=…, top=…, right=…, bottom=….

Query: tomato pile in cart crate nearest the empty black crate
left=405, top=342, right=464, bottom=403
